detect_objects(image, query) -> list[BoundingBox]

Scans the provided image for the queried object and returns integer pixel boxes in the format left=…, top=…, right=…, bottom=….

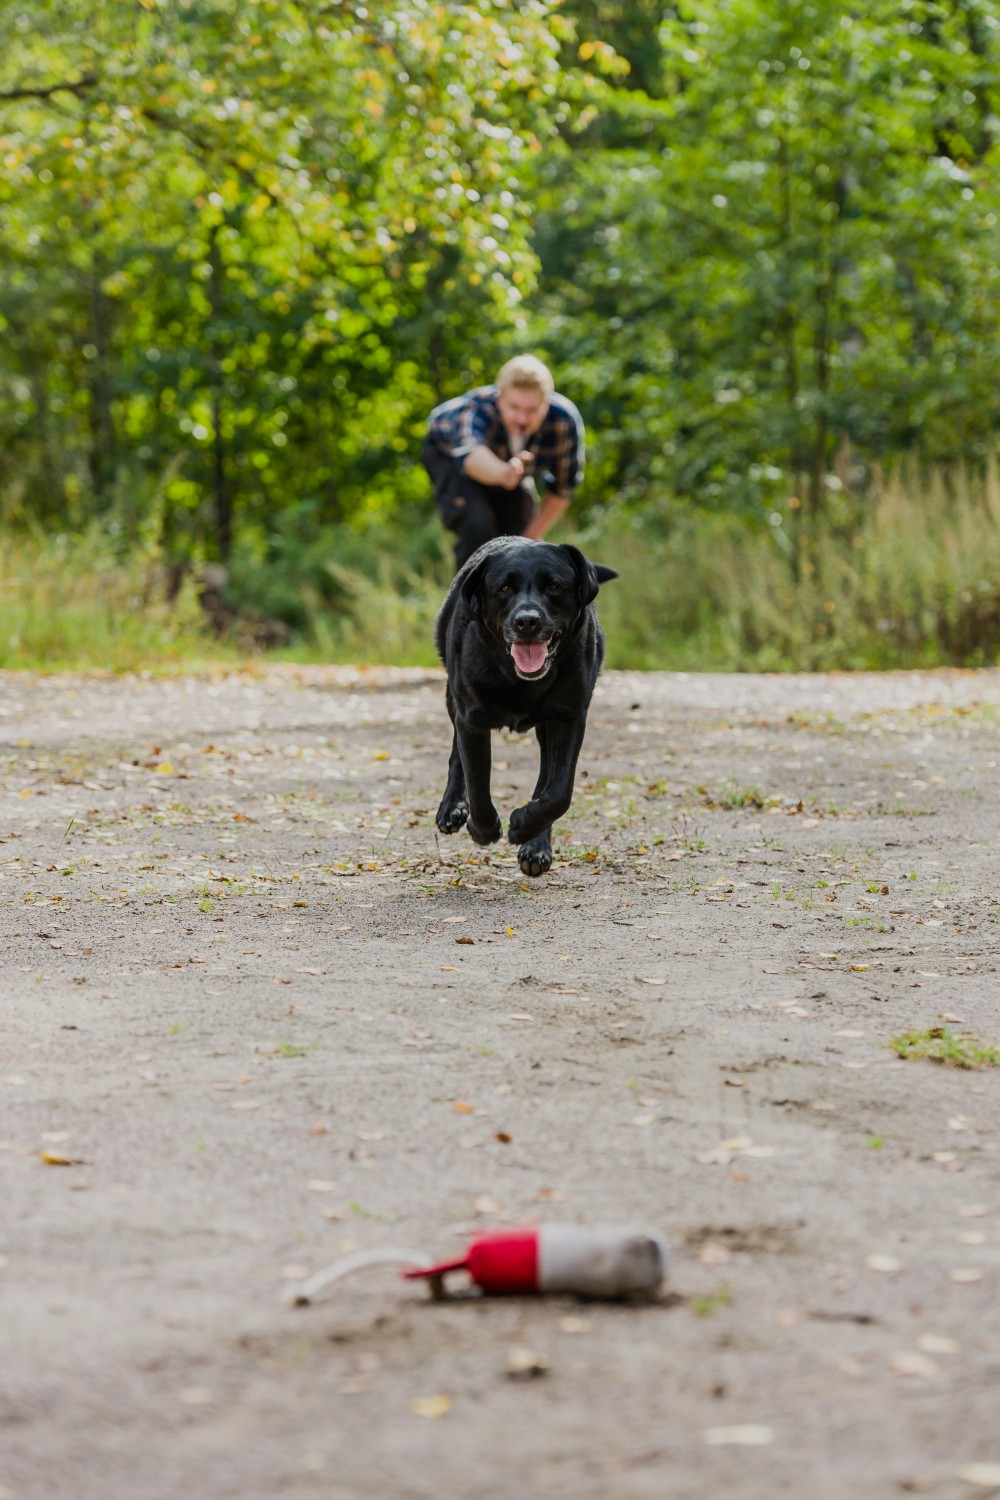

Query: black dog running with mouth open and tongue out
left=436, top=537, right=618, bottom=875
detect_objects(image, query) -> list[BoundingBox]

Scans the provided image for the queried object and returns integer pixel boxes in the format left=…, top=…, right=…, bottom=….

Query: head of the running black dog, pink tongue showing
left=460, top=537, right=618, bottom=683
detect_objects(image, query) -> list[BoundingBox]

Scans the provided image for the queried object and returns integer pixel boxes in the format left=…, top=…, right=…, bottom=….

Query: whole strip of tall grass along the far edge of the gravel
left=0, top=470, right=1000, bottom=671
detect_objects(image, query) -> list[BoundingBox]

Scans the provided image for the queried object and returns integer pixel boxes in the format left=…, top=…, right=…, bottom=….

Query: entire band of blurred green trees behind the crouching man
left=0, top=0, right=1000, bottom=669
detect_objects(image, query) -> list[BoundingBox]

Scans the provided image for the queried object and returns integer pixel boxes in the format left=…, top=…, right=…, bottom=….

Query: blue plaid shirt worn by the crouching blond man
left=430, top=386, right=583, bottom=500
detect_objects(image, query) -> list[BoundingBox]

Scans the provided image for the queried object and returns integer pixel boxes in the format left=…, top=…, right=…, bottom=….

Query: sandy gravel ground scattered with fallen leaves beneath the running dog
left=0, top=669, right=1000, bottom=1500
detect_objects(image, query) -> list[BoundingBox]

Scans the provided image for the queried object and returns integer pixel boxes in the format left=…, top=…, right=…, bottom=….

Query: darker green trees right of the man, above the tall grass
left=535, top=0, right=1000, bottom=534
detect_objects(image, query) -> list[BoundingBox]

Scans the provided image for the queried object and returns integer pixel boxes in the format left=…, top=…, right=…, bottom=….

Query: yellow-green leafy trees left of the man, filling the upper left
left=0, top=0, right=575, bottom=555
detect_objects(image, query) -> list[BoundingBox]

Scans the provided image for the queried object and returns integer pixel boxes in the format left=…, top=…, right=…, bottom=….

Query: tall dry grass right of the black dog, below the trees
left=585, top=456, right=1000, bottom=672
